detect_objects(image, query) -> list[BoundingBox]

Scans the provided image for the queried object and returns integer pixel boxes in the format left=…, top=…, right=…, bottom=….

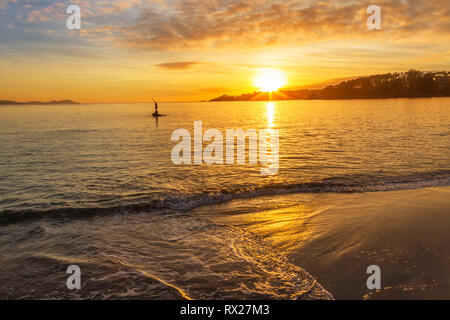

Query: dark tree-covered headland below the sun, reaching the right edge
left=210, top=70, right=450, bottom=101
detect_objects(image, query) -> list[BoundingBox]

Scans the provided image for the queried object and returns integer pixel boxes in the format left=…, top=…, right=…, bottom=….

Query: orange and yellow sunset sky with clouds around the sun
left=0, top=0, right=450, bottom=103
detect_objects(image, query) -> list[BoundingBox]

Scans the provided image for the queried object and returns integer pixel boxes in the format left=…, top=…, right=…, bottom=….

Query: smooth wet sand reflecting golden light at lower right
left=196, top=187, right=450, bottom=299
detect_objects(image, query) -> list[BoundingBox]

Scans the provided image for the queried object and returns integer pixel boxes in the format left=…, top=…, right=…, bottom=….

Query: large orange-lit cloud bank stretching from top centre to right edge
left=106, top=0, right=450, bottom=50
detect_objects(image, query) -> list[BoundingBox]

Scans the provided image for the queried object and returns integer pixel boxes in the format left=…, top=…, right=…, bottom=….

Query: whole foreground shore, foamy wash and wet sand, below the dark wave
left=0, top=186, right=450, bottom=300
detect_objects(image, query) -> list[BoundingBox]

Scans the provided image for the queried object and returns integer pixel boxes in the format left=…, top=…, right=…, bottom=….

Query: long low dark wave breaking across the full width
left=0, top=170, right=450, bottom=224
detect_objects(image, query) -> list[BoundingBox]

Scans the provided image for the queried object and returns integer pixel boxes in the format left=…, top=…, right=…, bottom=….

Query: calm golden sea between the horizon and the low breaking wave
left=0, top=98, right=450, bottom=213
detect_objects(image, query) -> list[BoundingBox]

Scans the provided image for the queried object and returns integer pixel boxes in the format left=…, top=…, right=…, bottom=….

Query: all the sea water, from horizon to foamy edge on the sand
left=0, top=98, right=450, bottom=299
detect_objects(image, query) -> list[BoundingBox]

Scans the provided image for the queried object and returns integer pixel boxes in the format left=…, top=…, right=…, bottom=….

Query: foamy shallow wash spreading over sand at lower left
left=0, top=206, right=333, bottom=300
